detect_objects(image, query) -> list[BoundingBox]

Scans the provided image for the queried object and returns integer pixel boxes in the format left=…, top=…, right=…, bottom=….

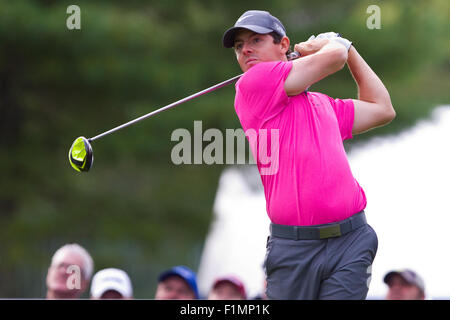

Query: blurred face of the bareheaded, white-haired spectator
left=47, top=251, right=87, bottom=297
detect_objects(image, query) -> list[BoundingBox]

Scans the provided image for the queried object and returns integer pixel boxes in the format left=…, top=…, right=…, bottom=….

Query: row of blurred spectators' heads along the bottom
left=46, top=243, right=425, bottom=300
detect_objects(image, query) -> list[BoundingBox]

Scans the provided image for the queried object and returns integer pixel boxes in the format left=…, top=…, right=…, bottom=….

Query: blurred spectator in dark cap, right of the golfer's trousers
left=384, top=269, right=425, bottom=300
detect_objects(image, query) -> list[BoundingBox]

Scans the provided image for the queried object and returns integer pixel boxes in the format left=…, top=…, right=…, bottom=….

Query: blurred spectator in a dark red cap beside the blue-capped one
left=208, top=276, right=247, bottom=300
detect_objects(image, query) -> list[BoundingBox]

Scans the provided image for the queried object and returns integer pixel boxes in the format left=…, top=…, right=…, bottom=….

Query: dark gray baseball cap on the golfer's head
left=222, top=10, right=286, bottom=48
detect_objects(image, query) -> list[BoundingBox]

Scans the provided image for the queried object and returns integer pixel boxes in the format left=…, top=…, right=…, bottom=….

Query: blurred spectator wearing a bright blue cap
left=155, top=266, right=199, bottom=300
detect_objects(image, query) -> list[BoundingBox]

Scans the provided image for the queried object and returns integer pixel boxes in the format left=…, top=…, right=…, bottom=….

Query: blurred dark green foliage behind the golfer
left=0, top=0, right=450, bottom=298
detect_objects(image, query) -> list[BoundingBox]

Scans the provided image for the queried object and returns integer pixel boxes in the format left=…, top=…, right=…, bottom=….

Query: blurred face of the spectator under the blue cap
left=155, top=276, right=195, bottom=300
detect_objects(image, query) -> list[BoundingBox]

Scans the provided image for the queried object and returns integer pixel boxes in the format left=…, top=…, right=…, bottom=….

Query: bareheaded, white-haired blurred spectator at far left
left=46, top=243, right=94, bottom=299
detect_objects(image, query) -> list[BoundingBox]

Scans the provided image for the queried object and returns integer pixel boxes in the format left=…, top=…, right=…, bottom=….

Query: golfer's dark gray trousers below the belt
left=264, top=224, right=378, bottom=300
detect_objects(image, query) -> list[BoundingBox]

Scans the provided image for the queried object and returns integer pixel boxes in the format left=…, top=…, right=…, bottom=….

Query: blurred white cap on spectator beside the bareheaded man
left=91, top=268, right=133, bottom=299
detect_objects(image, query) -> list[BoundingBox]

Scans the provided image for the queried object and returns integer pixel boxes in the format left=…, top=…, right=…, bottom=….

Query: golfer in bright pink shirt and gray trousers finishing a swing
left=223, top=10, right=395, bottom=299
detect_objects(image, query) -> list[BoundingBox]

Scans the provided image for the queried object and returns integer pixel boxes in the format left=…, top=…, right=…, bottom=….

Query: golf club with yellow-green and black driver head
left=69, top=51, right=300, bottom=172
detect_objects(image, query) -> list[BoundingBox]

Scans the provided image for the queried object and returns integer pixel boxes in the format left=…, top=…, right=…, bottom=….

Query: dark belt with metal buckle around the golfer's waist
left=270, top=210, right=367, bottom=240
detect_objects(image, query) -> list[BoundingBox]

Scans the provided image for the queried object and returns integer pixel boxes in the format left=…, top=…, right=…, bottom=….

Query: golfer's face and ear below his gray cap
left=234, top=29, right=289, bottom=72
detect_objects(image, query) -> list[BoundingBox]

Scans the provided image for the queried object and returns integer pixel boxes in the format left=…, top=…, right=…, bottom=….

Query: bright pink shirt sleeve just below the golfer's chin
left=236, top=61, right=292, bottom=120
